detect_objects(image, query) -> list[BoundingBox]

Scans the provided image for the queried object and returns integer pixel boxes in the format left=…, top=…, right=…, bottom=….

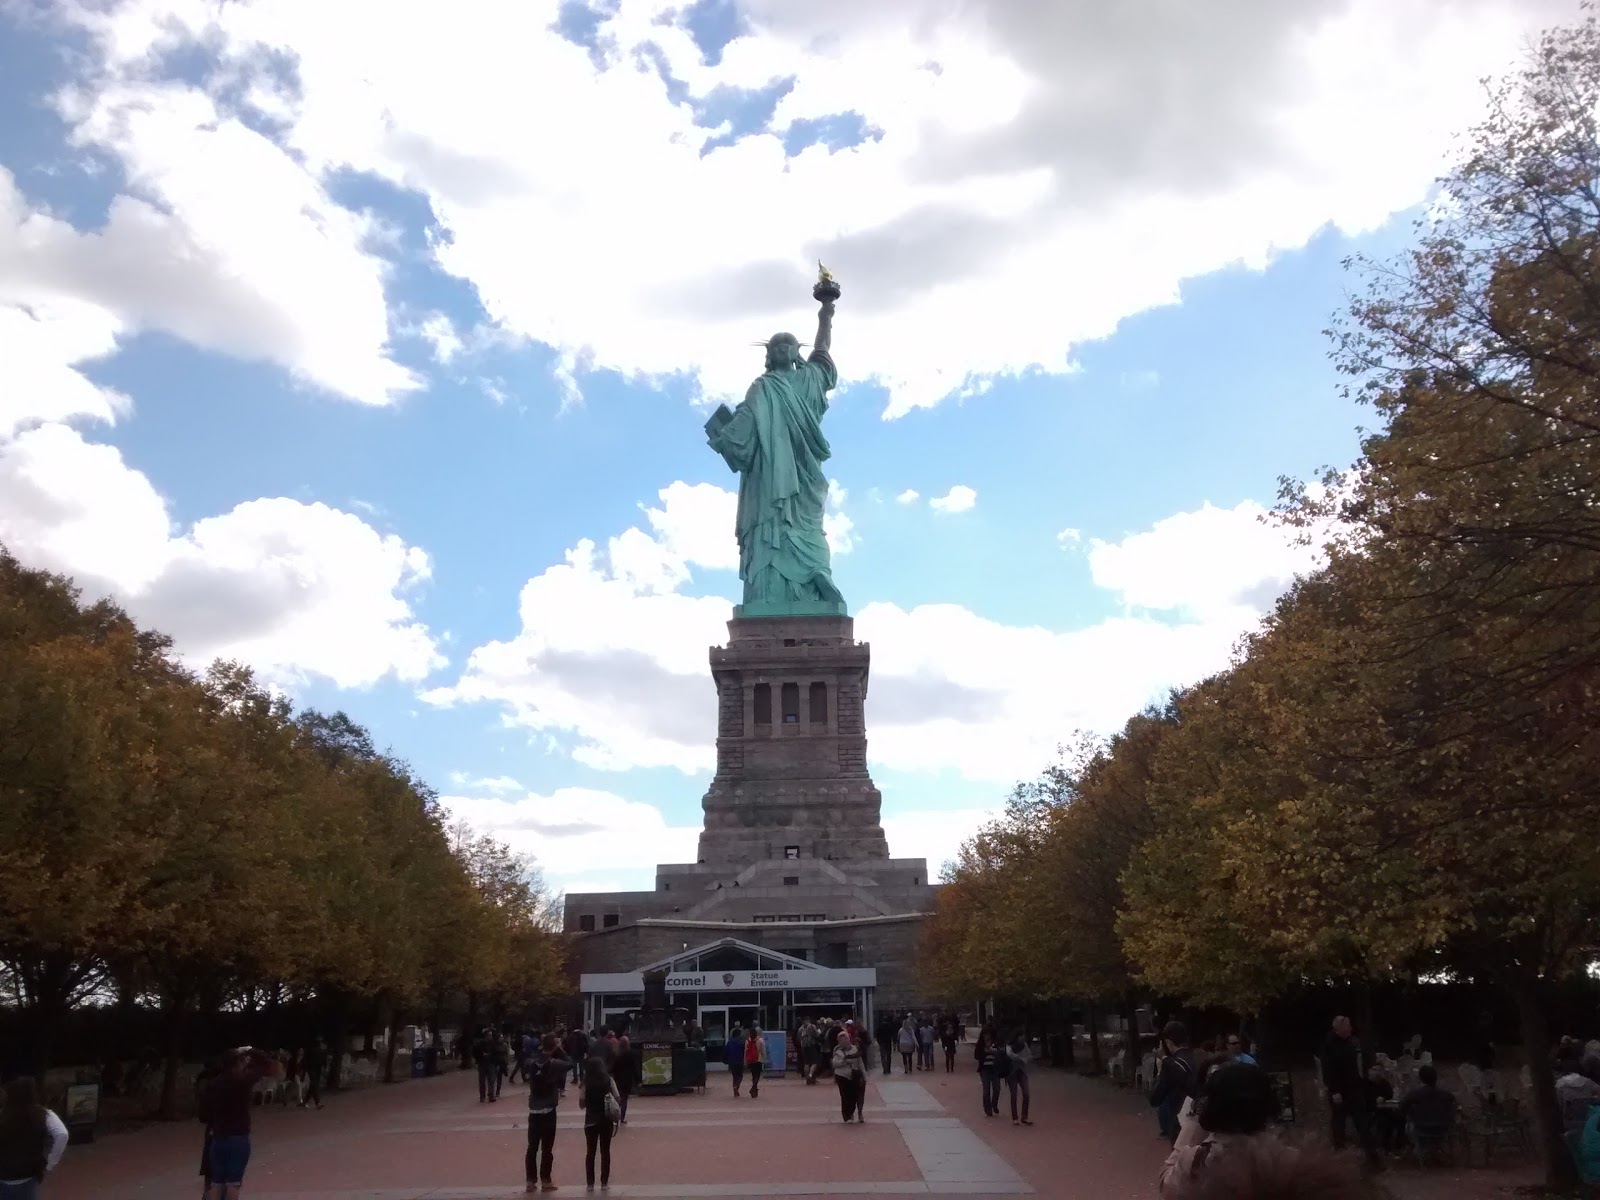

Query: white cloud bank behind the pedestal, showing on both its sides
left=427, top=485, right=1310, bottom=782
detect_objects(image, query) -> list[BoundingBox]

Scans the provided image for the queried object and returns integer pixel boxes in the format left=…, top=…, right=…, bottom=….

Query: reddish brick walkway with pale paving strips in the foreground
left=34, top=1069, right=1536, bottom=1200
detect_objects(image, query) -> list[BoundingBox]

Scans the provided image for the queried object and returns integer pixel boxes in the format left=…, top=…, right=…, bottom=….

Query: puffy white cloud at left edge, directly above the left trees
left=0, top=424, right=443, bottom=686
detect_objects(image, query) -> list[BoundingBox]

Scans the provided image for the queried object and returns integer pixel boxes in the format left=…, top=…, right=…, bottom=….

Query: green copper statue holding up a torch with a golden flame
left=706, top=262, right=848, bottom=616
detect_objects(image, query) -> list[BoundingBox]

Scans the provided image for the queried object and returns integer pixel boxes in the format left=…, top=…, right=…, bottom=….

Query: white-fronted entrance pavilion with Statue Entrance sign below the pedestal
left=578, top=938, right=878, bottom=1069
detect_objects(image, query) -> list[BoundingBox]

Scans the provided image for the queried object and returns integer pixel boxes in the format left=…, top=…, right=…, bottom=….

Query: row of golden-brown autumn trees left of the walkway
left=0, top=550, right=560, bottom=1115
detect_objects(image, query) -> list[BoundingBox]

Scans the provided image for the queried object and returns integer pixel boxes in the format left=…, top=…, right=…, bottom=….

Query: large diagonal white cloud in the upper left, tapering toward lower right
left=0, top=80, right=421, bottom=405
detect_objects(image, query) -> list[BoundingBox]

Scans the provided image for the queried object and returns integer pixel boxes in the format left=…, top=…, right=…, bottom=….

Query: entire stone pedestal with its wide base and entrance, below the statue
left=565, top=616, right=938, bottom=1017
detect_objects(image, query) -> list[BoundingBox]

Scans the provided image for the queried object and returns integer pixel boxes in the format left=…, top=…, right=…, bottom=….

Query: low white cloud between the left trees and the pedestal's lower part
left=440, top=787, right=699, bottom=891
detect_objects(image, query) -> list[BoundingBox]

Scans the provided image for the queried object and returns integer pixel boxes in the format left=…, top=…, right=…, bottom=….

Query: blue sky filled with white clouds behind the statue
left=0, top=0, right=1568, bottom=888
